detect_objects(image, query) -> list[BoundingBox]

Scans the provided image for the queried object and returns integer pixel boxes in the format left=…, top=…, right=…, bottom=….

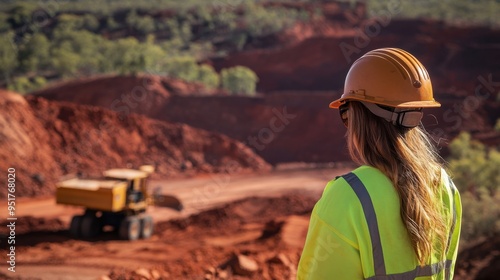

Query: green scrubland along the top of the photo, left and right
left=0, top=0, right=500, bottom=92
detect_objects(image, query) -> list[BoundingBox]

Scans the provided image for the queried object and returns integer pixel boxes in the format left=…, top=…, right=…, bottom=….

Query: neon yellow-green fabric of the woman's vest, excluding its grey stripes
left=297, top=166, right=462, bottom=280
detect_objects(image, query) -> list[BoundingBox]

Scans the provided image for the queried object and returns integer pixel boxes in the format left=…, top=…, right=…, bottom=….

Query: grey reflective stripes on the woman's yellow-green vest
left=341, top=172, right=456, bottom=280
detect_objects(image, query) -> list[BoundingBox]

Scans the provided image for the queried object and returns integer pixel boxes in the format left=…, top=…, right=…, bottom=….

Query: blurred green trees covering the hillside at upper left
left=0, top=1, right=308, bottom=94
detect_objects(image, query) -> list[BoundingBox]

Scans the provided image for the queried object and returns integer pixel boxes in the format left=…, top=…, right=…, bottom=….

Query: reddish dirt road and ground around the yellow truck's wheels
left=0, top=168, right=347, bottom=279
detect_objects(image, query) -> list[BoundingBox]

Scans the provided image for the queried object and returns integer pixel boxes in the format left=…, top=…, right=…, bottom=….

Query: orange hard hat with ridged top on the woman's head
left=330, top=48, right=441, bottom=109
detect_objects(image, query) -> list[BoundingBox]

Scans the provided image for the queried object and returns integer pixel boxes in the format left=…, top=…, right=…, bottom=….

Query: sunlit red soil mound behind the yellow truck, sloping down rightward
left=0, top=92, right=268, bottom=196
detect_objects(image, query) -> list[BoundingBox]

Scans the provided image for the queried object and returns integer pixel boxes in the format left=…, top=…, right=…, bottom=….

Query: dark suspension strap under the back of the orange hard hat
left=361, top=102, right=423, bottom=128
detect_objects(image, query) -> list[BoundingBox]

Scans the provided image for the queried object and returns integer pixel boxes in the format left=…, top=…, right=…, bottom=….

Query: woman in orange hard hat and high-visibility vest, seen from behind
left=297, top=48, right=461, bottom=280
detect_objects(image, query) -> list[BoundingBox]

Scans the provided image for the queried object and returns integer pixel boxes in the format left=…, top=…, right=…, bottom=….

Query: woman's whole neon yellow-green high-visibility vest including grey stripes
left=297, top=166, right=462, bottom=280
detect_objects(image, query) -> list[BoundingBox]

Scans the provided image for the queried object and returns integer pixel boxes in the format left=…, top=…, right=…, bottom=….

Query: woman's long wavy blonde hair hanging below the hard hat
left=347, top=101, right=448, bottom=266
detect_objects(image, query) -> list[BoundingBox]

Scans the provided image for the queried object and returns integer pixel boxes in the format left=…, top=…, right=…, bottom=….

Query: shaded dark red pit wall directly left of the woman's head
left=158, top=92, right=349, bottom=164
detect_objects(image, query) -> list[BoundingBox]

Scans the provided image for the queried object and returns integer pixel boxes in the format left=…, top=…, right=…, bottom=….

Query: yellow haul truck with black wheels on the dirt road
left=56, top=165, right=182, bottom=240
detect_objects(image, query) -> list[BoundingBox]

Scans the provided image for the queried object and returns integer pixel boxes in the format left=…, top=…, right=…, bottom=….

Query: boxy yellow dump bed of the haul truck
left=56, top=178, right=127, bottom=212
